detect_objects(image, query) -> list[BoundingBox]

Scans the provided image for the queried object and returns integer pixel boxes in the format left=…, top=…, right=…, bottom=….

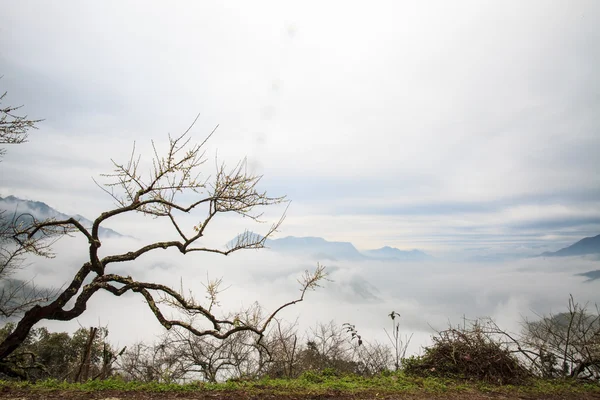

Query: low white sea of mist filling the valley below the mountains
left=14, top=234, right=600, bottom=351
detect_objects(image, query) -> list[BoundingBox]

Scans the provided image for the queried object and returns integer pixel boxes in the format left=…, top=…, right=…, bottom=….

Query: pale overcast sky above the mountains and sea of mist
left=0, top=0, right=600, bottom=254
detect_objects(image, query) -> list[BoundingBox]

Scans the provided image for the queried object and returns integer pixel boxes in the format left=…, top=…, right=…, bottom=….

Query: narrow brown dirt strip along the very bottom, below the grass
left=0, top=389, right=600, bottom=400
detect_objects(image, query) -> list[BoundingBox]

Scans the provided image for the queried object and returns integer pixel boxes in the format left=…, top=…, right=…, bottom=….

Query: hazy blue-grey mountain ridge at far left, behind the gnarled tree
left=0, top=196, right=123, bottom=238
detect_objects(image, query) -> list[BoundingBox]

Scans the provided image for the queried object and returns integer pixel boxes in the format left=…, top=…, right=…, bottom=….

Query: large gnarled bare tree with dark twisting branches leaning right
left=0, top=119, right=325, bottom=376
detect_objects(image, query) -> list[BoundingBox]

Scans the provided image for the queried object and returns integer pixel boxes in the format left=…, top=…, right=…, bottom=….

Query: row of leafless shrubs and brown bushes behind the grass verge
left=0, top=298, right=600, bottom=386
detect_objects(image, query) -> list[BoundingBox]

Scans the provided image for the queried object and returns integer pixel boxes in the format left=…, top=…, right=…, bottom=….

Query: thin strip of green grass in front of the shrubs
left=0, top=372, right=600, bottom=395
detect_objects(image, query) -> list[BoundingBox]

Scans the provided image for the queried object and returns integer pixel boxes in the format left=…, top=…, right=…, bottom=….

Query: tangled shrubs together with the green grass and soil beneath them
left=0, top=308, right=600, bottom=400
